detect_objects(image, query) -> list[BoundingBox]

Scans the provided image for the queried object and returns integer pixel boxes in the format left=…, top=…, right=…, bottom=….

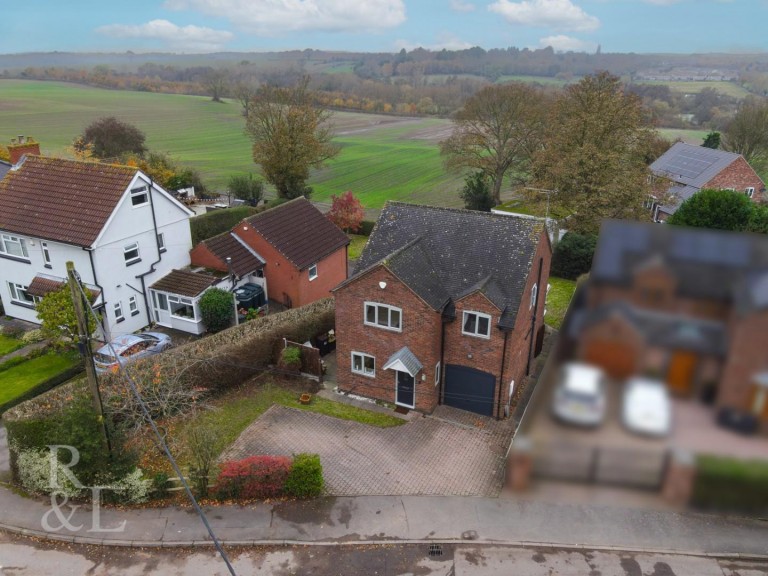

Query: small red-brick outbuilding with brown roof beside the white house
left=190, top=197, right=349, bottom=307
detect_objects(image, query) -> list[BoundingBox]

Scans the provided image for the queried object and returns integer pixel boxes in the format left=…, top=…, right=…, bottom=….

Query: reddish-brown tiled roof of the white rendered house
left=0, top=156, right=136, bottom=247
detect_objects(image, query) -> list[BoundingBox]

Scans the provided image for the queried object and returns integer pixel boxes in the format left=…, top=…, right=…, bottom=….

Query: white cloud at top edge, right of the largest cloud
left=488, top=0, right=600, bottom=32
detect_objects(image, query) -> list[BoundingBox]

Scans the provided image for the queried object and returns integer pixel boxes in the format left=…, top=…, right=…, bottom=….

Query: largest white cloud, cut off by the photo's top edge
left=165, top=0, right=405, bottom=36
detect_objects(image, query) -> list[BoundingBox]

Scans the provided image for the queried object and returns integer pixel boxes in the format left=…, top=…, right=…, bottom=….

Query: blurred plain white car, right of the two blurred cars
left=621, top=376, right=672, bottom=436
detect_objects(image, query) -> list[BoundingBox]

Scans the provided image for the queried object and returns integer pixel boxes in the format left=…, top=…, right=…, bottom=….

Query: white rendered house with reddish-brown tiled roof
left=0, top=155, right=193, bottom=337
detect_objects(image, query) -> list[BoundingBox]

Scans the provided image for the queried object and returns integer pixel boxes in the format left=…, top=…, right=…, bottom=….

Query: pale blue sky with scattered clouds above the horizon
left=0, top=0, right=768, bottom=54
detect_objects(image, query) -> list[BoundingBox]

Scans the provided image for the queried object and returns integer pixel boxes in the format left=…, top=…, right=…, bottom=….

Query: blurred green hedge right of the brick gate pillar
left=691, top=456, right=768, bottom=515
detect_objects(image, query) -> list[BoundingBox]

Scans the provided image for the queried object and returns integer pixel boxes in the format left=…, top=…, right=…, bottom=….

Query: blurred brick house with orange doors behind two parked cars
left=565, top=221, right=768, bottom=427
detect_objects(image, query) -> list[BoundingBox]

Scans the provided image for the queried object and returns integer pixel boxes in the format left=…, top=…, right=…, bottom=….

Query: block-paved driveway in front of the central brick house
left=222, top=406, right=511, bottom=496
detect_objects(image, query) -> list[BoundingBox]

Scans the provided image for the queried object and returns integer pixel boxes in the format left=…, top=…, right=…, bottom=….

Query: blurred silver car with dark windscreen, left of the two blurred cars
left=552, top=362, right=606, bottom=426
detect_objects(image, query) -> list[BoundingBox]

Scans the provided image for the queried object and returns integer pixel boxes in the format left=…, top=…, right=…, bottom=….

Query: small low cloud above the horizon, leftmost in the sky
left=96, top=20, right=233, bottom=52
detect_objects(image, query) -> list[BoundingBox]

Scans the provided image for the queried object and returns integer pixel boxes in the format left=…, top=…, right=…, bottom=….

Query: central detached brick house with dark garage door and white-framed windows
left=333, top=202, right=551, bottom=418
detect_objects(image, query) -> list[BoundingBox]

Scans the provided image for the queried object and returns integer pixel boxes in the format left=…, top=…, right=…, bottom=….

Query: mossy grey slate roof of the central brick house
left=342, top=201, right=544, bottom=325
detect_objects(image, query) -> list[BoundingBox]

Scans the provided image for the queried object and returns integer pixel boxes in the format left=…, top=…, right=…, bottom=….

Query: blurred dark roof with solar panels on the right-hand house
left=590, top=220, right=768, bottom=306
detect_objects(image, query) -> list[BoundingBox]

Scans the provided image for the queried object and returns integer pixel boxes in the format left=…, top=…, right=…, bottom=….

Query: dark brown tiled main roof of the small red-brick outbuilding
left=246, top=197, right=349, bottom=270
